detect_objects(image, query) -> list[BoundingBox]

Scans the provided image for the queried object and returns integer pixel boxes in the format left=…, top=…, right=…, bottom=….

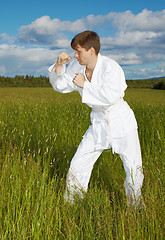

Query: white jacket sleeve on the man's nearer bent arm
left=82, top=60, right=127, bottom=106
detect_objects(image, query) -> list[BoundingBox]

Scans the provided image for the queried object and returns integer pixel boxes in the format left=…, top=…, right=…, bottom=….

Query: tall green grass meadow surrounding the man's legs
left=0, top=88, right=165, bottom=240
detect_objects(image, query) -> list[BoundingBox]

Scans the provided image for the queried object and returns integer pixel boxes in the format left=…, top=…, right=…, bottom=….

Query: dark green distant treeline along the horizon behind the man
left=0, top=75, right=165, bottom=90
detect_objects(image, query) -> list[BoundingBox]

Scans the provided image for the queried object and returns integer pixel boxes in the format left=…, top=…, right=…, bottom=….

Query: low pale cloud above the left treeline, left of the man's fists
left=0, top=44, right=62, bottom=76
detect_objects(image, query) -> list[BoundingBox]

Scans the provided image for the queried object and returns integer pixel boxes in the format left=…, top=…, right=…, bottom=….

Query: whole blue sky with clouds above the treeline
left=0, top=0, right=165, bottom=79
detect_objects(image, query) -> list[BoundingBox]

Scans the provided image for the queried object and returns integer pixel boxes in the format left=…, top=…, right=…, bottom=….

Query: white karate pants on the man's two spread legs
left=64, top=127, right=144, bottom=204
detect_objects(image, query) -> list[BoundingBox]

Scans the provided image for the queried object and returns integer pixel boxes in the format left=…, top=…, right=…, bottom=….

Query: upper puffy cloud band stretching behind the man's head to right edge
left=18, top=9, right=165, bottom=53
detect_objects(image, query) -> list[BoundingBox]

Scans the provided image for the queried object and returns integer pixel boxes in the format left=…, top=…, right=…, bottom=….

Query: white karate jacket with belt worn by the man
left=48, top=54, right=137, bottom=149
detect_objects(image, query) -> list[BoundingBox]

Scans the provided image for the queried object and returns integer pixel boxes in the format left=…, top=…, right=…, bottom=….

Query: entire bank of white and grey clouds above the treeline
left=0, top=9, right=165, bottom=78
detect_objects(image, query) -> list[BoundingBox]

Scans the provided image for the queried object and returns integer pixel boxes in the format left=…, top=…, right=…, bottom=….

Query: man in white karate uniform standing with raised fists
left=49, top=31, right=143, bottom=205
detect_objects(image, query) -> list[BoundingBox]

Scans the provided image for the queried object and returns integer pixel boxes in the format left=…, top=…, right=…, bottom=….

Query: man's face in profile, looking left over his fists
left=74, top=45, right=91, bottom=65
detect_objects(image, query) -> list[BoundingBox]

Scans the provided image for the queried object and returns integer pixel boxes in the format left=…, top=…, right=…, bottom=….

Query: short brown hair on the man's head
left=71, top=31, right=100, bottom=54
